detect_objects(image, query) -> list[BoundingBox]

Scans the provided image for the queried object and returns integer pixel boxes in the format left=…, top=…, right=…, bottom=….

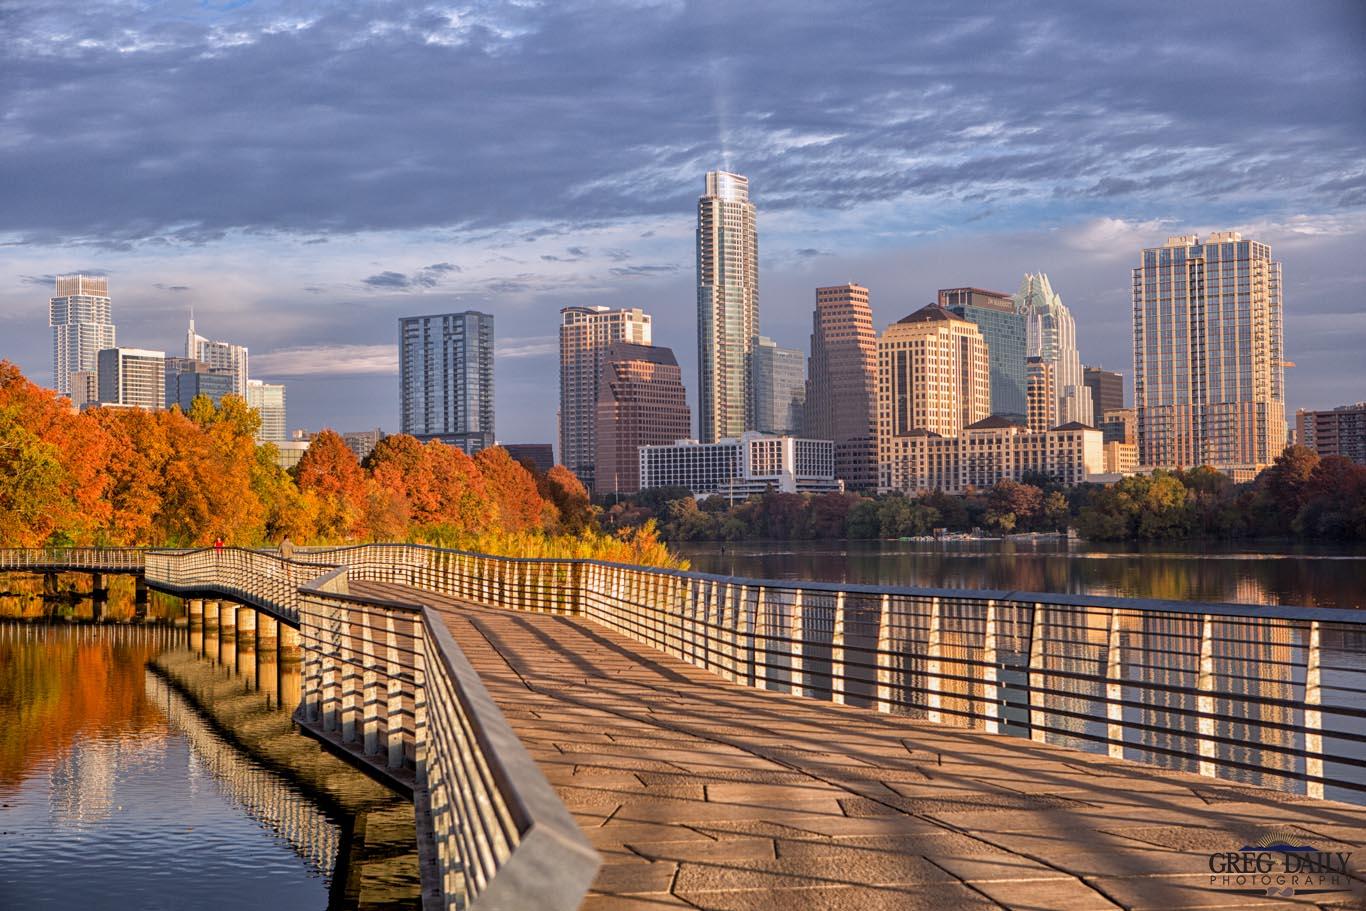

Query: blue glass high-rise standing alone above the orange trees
left=399, top=310, right=493, bottom=455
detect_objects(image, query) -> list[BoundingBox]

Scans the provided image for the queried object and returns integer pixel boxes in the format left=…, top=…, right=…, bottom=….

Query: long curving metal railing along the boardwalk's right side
left=290, top=545, right=1366, bottom=802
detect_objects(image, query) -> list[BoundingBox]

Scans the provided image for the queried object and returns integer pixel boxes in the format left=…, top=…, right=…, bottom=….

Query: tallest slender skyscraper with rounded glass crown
left=697, top=171, right=759, bottom=443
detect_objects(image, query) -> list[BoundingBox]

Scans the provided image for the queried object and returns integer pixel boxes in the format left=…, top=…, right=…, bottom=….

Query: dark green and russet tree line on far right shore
left=604, top=447, right=1366, bottom=542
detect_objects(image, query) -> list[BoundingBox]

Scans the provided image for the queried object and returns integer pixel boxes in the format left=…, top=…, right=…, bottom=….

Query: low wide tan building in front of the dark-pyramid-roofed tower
left=878, top=417, right=1105, bottom=493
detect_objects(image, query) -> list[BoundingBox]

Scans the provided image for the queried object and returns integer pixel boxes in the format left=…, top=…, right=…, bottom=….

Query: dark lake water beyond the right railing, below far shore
left=672, top=538, right=1366, bottom=608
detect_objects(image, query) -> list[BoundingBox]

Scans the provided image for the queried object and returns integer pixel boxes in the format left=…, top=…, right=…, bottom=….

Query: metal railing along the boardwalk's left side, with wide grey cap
left=146, top=548, right=601, bottom=911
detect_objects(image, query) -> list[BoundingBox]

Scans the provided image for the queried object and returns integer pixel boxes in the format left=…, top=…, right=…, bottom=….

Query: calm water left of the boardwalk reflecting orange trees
left=0, top=620, right=344, bottom=910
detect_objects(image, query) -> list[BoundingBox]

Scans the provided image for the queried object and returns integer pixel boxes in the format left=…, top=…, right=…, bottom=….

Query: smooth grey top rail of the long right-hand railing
left=293, top=541, right=1366, bottom=626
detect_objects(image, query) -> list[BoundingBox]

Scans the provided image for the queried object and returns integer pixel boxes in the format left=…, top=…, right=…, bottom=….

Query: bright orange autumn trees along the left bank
left=0, top=362, right=678, bottom=565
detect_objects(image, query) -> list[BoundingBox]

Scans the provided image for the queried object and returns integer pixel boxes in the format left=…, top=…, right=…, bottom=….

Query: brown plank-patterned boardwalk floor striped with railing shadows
left=351, top=582, right=1366, bottom=911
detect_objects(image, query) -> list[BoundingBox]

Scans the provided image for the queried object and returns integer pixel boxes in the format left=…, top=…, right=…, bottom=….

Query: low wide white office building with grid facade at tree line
left=641, top=433, right=841, bottom=501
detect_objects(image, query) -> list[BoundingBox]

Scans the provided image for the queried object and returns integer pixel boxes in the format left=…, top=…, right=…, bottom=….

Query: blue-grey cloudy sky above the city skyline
left=0, top=0, right=1366, bottom=443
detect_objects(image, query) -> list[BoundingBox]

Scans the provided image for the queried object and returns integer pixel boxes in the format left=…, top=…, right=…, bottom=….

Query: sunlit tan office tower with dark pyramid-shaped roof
left=877, top=303, right=992, bottom=442
